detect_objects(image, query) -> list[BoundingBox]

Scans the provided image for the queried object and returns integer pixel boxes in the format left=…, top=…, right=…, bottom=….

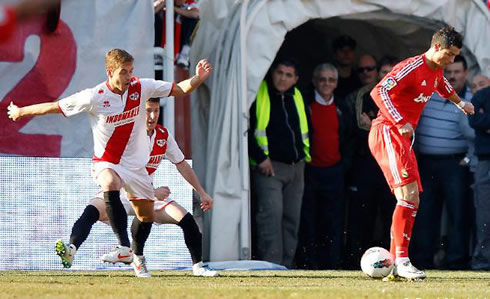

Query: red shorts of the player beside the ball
left=369, top=121, right=422, bottom=192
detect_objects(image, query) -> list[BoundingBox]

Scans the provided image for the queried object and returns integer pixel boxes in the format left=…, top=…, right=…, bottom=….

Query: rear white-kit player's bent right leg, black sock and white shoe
left=155, top=201, right=218, bottom=276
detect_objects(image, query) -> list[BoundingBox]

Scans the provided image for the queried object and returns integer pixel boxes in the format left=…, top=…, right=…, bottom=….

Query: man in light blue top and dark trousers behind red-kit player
left=412, top=55, right=474, bottom=270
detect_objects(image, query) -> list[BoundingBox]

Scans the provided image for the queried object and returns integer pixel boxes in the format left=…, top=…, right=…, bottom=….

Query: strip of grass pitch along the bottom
left=0, top=270, right=490, bottom=299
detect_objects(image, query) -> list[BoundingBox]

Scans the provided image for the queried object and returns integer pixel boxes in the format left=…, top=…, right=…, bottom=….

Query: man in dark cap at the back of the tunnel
left=332, top=35, right=361, bottom=99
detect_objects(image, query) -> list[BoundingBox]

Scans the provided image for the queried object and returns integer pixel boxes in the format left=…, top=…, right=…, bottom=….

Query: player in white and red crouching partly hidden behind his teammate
left=55, top=98, right=218, bottom=277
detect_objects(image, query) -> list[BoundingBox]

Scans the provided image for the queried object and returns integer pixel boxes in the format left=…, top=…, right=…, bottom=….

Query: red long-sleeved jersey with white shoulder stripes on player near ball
left=371, top=54, right=454, bottom=129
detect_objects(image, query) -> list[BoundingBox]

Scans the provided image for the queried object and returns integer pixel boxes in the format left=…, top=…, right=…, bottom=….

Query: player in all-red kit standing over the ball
left=369, top=26, right=474, bottom=280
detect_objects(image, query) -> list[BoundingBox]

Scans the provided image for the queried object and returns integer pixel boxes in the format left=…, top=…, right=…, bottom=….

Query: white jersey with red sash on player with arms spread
left=58, top=77, right=174, bottom=170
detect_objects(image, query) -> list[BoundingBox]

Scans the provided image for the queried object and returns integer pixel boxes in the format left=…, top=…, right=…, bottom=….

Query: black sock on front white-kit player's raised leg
left=104, top=191, right=130, bottom=247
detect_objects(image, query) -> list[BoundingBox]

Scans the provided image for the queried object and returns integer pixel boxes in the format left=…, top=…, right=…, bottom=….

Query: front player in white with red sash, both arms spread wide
left=8, top=49, right=212, bottom=264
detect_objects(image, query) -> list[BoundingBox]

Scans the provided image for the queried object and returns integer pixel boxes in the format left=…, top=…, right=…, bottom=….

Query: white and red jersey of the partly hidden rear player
left=146, top=125, right=184, bottom=175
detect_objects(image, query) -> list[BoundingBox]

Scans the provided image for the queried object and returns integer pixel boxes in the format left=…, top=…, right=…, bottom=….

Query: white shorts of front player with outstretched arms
left=92, top=162, right=155, bottom=200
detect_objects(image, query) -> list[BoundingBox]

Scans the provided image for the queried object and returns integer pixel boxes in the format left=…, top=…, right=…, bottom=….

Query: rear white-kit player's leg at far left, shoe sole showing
left=55, top=197, right=106, bottom=268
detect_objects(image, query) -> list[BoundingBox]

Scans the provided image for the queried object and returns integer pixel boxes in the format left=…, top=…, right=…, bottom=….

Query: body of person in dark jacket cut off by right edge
left=470, top=86, right=490, bottom=270
